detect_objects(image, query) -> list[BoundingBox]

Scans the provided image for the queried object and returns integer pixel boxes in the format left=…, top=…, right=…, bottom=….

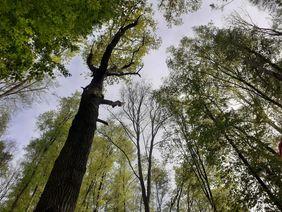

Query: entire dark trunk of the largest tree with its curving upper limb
left=35, top=18, right=139, bottom=212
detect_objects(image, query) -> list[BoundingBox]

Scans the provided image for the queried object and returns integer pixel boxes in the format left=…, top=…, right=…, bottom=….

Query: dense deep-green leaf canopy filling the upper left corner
left=0, top=0, right=119, bottom=81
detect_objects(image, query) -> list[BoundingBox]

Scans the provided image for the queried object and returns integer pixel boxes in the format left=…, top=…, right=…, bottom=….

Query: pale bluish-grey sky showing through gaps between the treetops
left=5, top=0, right=270, bottom=159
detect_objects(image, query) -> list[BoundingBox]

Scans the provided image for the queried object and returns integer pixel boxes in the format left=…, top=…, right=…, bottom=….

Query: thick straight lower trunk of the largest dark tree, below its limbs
left=35, top=83, right=102, bottom=212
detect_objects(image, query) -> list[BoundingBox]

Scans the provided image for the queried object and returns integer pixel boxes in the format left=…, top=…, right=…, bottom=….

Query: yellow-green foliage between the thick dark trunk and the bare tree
left=76, top=122, right=136, bottom=211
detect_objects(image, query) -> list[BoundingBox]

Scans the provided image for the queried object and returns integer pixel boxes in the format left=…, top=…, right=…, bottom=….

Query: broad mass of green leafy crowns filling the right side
left=158, top=20, right=282, bottom=210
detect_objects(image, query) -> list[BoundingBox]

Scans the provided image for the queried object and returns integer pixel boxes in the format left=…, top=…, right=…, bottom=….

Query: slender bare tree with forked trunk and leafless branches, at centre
left=110, top=83, right=166, bottom=211
